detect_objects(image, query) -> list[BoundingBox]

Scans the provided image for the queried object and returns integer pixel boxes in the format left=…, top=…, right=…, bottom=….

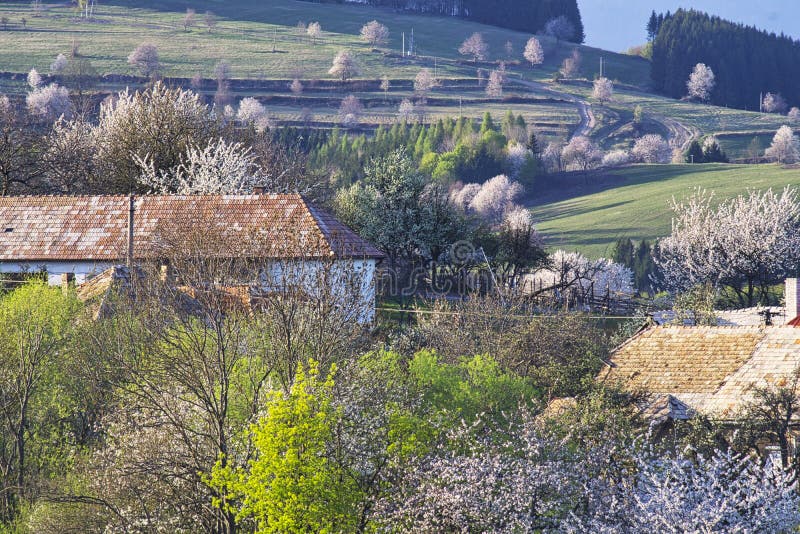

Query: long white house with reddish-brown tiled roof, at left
left=0, top=194, right=383, bottom=321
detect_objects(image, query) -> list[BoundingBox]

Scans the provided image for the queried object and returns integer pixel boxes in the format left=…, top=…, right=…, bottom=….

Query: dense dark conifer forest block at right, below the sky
left=648, top=9, right=800, bottom=109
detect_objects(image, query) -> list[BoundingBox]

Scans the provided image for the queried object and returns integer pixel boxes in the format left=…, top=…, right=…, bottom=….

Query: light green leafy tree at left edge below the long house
left=0, top=281, right=79, bottom=521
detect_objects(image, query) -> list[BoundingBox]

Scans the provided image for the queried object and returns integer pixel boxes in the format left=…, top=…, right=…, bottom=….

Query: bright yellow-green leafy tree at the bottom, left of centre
left=210, top=360, right=361, bottom=533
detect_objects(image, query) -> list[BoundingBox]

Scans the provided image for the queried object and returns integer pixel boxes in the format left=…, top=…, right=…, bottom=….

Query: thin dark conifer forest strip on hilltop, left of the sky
left=304, top=0, right=584, bottom=43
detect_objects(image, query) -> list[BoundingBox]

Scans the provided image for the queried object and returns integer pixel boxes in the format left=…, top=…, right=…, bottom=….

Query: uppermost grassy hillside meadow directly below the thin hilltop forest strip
left=0, top=0, right=648, bottom=85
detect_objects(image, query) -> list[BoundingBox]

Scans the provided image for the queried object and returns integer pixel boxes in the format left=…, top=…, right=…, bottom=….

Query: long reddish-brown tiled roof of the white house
left=0, top=195, right=383, bottom=261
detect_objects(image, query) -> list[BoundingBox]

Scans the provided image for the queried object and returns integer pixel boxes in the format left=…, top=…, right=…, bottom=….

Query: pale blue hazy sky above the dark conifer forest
left=578, top=0, right=800, bottom=52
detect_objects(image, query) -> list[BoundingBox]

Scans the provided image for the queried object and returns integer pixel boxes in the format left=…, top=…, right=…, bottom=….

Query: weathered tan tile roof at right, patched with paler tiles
left=598, top=326, right=800, bottom=417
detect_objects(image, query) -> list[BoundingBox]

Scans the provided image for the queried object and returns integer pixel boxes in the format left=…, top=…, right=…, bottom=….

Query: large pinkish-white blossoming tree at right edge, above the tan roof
left=654, top=188, right=800, bottom=306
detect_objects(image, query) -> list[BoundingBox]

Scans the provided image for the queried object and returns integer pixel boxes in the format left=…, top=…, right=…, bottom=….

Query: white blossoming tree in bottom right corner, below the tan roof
left=567, top=450, right=800, bottom=534
